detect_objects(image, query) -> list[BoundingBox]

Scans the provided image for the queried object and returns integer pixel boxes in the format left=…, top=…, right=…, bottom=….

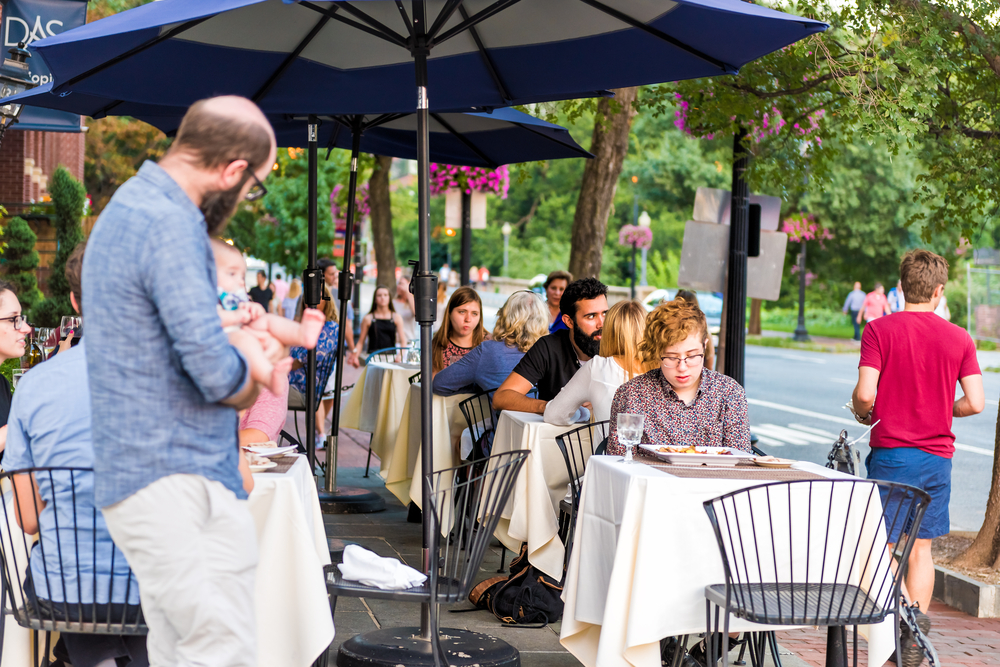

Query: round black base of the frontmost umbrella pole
left=337, top=628, right=521, bottom=667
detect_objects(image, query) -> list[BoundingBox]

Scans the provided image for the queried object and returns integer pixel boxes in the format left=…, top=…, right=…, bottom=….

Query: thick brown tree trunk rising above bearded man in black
left=569, top=88, right=638, bottom=278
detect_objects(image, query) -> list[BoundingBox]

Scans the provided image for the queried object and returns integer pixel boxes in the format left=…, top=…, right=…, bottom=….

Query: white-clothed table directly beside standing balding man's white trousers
left=248, top=454, right=334, bottom=667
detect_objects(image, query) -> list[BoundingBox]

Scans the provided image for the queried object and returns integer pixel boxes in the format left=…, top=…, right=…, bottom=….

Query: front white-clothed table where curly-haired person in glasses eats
left=560, top=456, right=896, bottom=667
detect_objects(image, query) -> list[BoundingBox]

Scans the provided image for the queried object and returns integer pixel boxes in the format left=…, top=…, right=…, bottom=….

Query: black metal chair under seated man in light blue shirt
left=0, top=467, right=147, bottom=665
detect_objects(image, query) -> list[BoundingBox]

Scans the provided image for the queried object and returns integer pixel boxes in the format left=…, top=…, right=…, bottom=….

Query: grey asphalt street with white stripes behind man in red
left=745, top=345, right=1000, bottom=530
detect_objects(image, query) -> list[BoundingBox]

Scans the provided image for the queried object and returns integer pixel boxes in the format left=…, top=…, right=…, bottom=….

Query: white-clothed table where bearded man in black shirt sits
left=491, top=410, right=583, bottom=581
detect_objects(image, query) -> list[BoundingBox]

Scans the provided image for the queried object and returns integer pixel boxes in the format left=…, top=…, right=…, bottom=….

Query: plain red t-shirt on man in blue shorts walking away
left=858, top=311, right=982, bottom=459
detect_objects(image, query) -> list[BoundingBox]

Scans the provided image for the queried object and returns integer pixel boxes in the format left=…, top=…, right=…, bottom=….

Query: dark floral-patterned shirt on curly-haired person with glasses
left=608, top=368, right=750, bottom=454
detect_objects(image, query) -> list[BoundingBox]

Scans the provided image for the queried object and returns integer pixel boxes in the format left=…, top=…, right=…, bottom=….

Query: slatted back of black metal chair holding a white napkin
left=424, top=450, right=528, bottom=603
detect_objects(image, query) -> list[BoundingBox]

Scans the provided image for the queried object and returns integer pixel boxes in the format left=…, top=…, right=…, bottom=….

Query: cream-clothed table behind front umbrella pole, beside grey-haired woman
left=379, top=382, right=472, bottom=509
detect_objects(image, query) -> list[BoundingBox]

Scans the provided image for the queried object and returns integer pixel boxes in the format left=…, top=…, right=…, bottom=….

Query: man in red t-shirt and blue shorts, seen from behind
left=853, top=250, right=985, bottom=667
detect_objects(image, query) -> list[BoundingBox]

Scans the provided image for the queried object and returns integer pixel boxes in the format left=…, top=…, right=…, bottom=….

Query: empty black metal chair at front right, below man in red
left=704, top=479, right=930, bottom=667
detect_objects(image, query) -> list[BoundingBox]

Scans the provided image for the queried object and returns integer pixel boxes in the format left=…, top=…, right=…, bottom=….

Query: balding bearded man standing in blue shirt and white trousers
left=83, top=97, right=286, bottom=667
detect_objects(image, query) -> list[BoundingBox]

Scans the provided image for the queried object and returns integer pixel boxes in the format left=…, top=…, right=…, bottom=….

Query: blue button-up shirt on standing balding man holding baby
left=83, top=162, right=248, bottom=507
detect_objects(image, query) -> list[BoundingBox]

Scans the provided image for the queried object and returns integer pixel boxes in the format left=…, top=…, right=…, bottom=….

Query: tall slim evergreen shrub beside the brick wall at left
left=31, top=166, right=87, bottom=327
